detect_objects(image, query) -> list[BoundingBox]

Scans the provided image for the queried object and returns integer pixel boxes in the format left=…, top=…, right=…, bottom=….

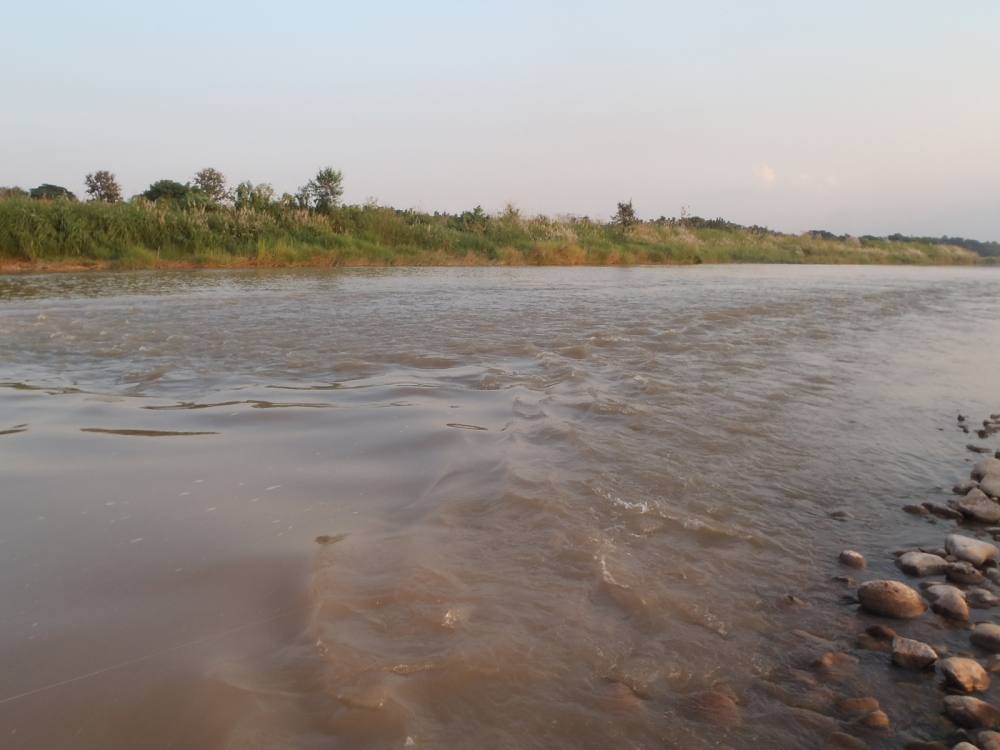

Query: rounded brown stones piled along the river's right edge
left=828, top=414, right=1000, bottom=750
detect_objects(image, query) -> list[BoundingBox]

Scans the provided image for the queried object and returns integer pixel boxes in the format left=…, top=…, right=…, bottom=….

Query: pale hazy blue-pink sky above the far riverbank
left=0, top=0, right=1000, bottom=240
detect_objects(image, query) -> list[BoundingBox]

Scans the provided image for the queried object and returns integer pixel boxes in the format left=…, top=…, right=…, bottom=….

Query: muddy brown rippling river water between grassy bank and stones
left=0, top=266, right=1000, bottom=750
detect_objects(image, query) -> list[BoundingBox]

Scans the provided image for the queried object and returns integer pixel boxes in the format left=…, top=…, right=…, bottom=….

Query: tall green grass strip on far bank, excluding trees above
left=0, top=197, right=977, bottom=268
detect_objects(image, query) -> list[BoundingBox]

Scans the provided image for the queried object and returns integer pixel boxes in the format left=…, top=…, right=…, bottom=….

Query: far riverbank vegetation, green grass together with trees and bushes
left=0, top=168, right=1000, bottom=273
